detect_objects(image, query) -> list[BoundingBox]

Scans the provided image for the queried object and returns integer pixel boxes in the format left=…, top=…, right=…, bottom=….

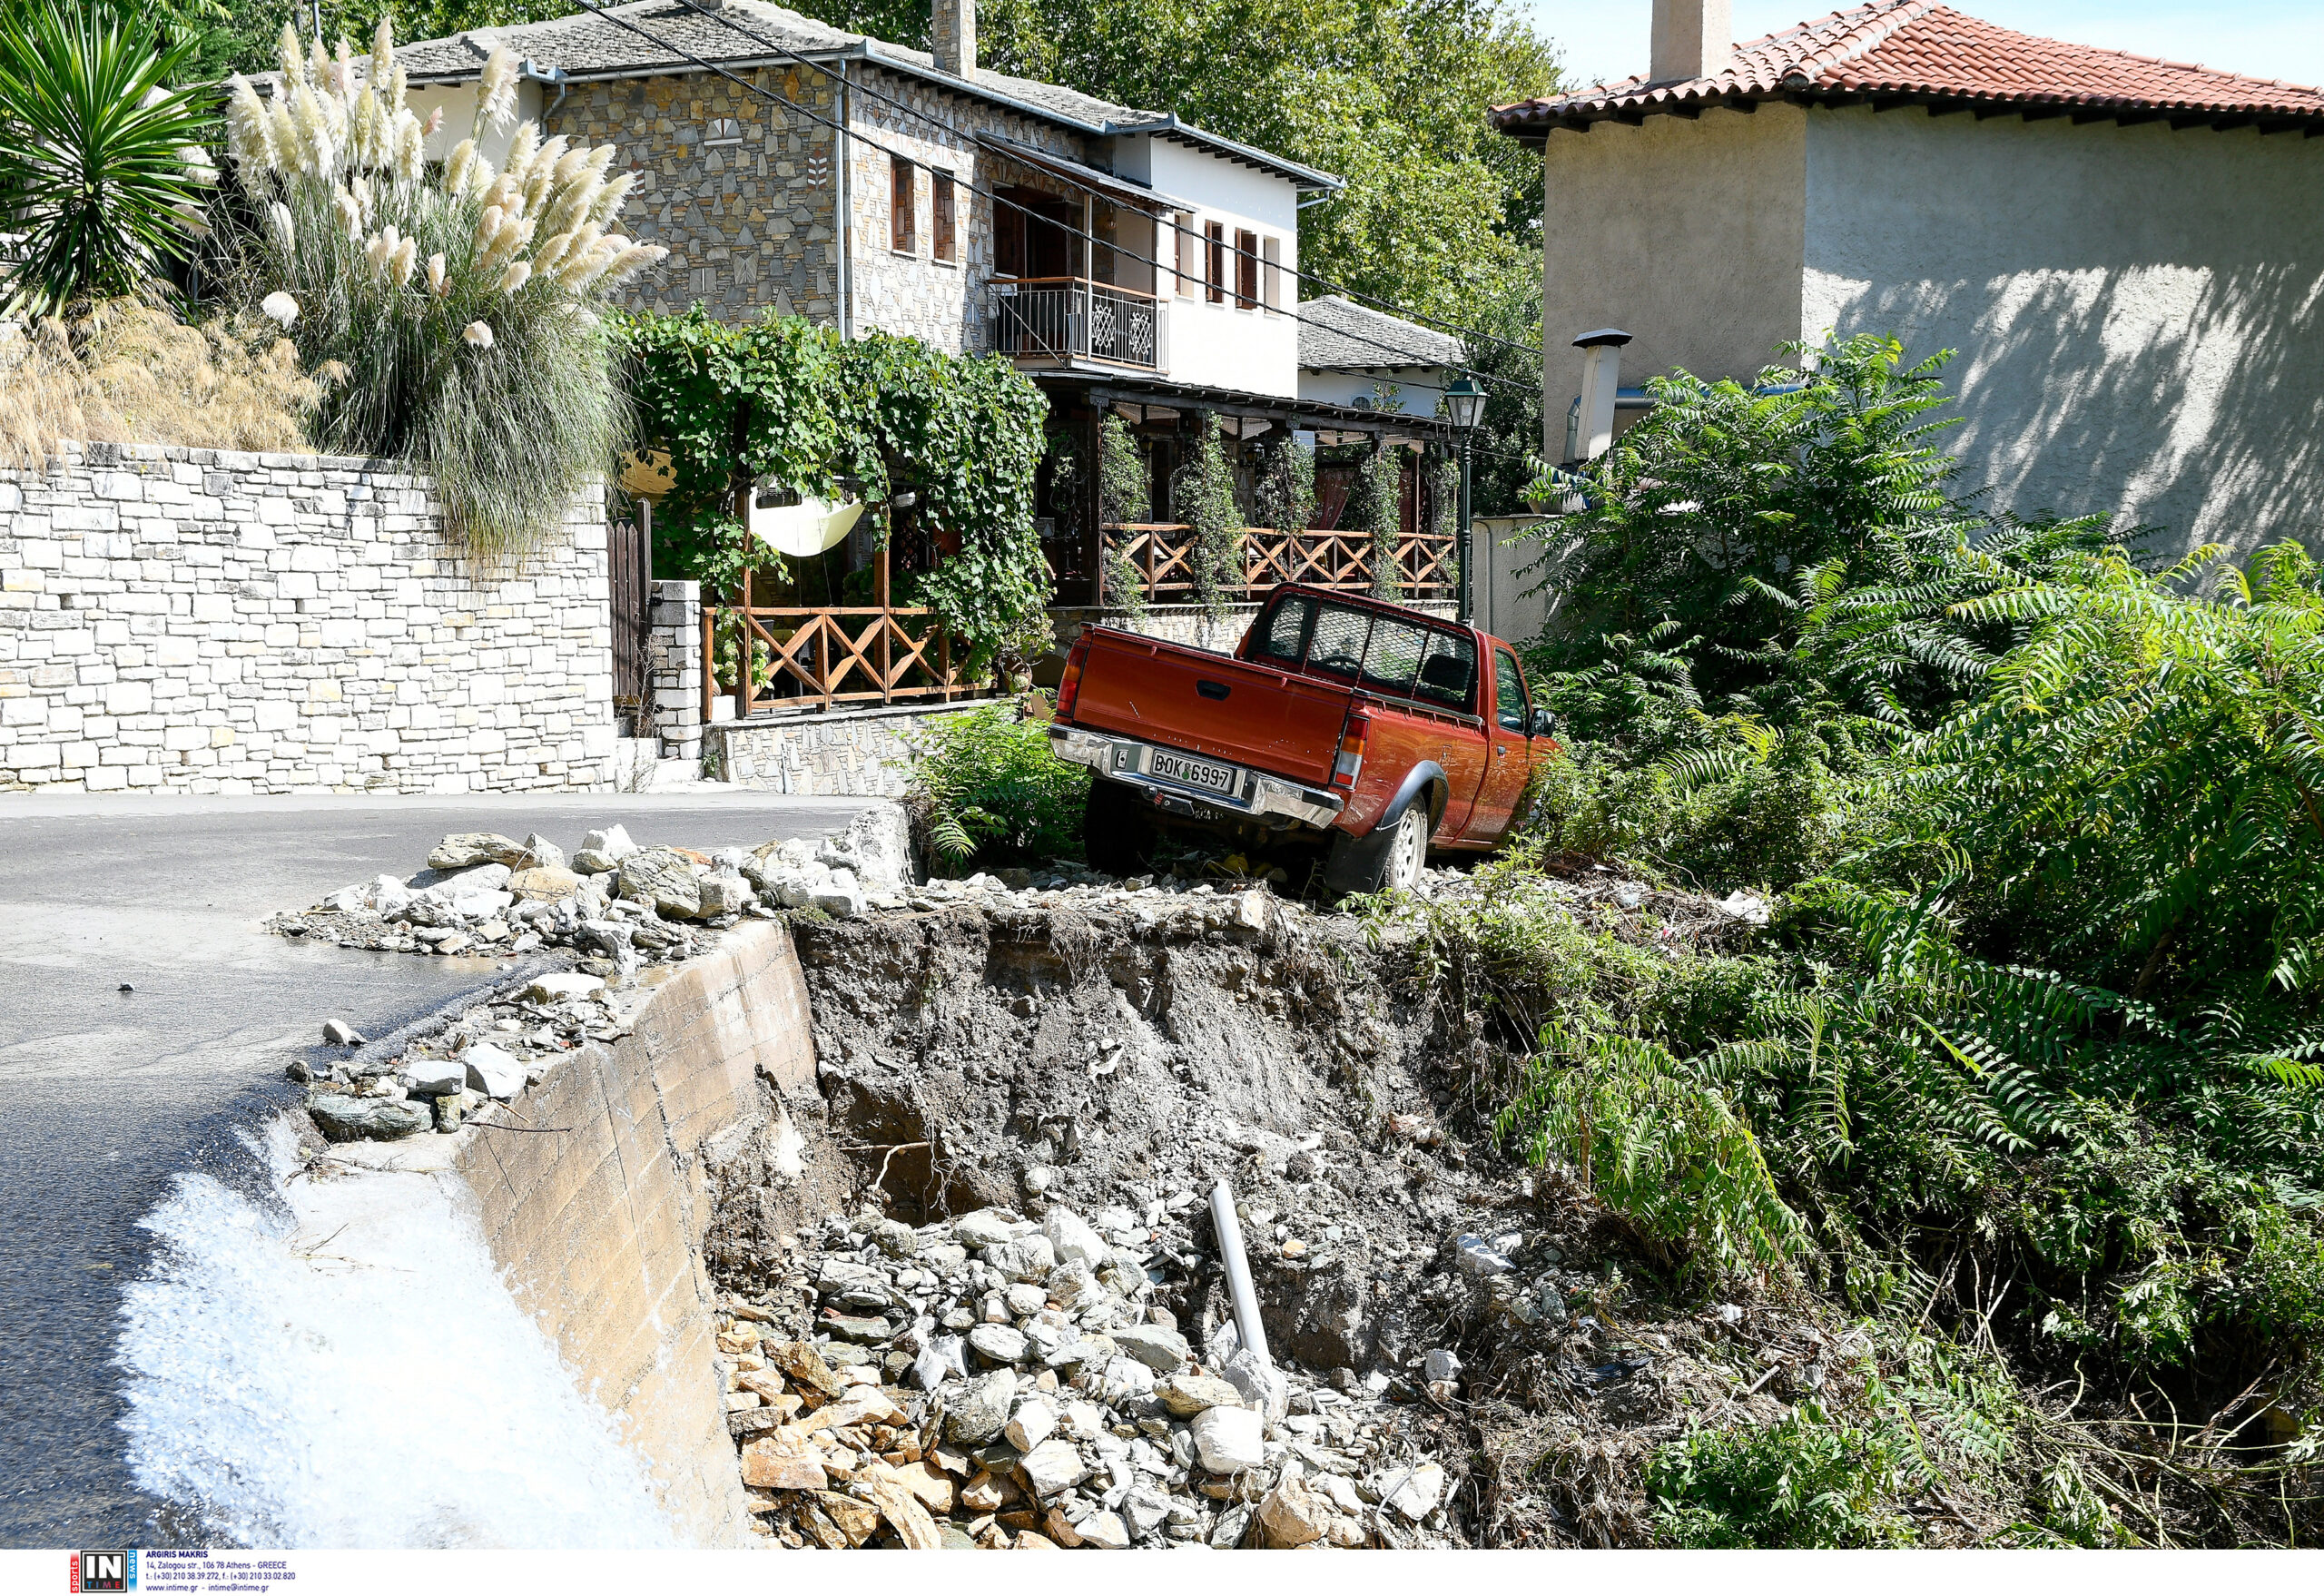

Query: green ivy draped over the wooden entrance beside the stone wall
left=625, top=304, right=1050, bottom=676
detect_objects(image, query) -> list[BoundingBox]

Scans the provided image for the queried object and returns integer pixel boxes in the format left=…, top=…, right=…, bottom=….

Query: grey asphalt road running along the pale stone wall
left=0, top=793, right=860, bottom=1547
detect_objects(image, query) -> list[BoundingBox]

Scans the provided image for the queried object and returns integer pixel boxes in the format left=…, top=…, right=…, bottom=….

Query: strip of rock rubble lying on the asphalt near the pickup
left=270, top=806, right=913, bottom=978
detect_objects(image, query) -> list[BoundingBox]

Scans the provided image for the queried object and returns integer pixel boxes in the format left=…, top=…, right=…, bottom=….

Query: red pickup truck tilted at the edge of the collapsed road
left=1049, top=586, right=1555, bottom=897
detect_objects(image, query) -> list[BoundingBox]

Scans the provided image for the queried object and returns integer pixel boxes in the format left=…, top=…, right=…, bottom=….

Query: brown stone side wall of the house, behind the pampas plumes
left=544, top=67, right=839, bottom=320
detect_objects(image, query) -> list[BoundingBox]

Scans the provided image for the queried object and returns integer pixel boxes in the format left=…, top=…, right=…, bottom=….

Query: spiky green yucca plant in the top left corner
left=0, top=7, right=216, bottom=319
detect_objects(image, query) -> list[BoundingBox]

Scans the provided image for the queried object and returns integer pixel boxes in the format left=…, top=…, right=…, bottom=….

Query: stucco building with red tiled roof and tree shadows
left=1494, top=0, right=2324, bottom=562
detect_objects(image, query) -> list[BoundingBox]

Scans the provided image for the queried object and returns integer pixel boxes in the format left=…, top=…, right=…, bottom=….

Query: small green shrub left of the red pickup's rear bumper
left=911, top=704, right=1090, bottom=869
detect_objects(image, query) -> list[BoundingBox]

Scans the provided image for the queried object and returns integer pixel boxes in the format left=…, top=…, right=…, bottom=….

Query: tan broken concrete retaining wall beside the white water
left=453, top=922, right=816, bottom=1545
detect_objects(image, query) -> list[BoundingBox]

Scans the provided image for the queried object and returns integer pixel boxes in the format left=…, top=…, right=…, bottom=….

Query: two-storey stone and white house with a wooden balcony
left=398, top=0, right=1441, bottom=602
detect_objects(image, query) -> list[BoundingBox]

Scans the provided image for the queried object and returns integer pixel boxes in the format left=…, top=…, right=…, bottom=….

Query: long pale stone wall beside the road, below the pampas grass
left=0, top=446, right=614, bottom=793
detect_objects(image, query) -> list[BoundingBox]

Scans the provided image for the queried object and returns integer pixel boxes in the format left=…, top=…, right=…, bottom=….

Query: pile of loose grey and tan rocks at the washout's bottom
left=718, top=1189, right=1462, bottom=1550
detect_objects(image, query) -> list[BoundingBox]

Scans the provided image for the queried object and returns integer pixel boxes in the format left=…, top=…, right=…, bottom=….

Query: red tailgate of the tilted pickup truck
left=1074, top=629, right=1350, bottom=785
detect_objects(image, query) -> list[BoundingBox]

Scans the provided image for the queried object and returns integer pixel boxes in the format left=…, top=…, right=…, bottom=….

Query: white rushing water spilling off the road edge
left=113, top=1119, right=674, bottom=1547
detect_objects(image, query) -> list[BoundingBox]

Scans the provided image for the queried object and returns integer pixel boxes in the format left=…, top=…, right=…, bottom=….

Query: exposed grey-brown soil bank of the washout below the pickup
left=709, top=888, right=1886, bottom=1545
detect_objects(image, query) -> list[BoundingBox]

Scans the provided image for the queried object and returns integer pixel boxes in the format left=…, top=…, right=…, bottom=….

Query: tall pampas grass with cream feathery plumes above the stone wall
left=228, top=21, right=667, bottom=565
